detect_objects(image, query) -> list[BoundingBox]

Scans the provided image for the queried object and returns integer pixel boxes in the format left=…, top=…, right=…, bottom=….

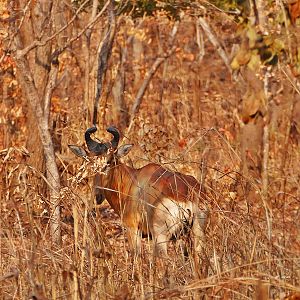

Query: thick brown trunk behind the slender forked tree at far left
left=18, top=0, right=52, bottom=195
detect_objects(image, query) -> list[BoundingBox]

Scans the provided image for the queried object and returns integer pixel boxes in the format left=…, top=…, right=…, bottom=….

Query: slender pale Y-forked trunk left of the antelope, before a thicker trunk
left=14, top=12, right=61, bottom=245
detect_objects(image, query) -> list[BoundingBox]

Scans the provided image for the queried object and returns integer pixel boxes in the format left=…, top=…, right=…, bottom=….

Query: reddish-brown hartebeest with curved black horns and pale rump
left=69, top=126, right=207, bottom=256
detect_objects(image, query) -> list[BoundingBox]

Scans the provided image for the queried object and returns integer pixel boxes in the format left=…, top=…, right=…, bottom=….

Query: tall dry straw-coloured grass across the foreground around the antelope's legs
left=0, top=132, right=300, bottom=299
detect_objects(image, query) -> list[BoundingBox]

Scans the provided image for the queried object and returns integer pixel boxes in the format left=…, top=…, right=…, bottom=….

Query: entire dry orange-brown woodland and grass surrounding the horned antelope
left=0, top=0, right=300, bottom=299
